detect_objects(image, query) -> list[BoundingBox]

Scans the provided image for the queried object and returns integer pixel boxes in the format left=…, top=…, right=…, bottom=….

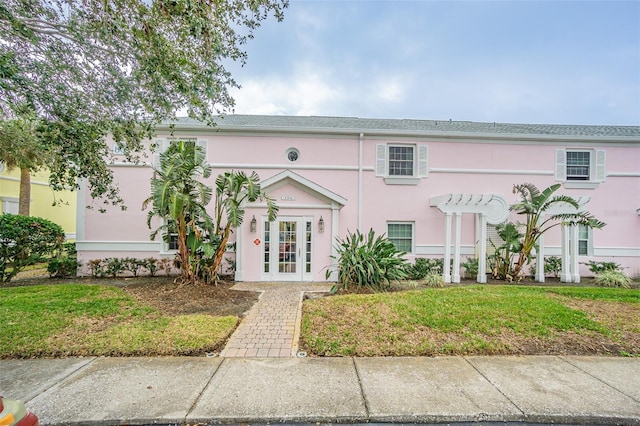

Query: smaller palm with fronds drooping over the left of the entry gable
left=211, top=171, right=278, bottom=273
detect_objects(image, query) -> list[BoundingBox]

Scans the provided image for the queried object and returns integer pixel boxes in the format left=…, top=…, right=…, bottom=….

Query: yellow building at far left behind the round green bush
left=0, top=163, right=77, bottom=240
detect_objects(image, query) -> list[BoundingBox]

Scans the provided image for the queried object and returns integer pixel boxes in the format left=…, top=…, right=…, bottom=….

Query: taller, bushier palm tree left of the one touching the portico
left=143, top=141, right=212, bottom=284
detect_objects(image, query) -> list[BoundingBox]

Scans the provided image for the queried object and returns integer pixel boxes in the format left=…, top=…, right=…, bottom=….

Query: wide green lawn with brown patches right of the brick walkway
left=301, top=285, right=640, bottom=356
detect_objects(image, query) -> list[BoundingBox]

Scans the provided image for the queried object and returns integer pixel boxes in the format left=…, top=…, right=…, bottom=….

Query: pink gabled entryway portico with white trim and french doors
left=235, top=170, right=347, bottom=282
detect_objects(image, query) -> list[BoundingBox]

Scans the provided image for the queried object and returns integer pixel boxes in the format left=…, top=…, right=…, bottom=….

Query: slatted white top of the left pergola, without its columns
left=429, top=193, right=509, bottom=225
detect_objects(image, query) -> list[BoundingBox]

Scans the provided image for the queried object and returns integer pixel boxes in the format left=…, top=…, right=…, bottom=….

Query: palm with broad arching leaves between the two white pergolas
left=511, top=183, right=605, bottom=278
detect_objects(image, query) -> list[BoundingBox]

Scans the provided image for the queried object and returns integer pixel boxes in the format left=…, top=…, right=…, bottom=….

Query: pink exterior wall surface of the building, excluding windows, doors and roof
left=78, top=120, right=640, bottom=281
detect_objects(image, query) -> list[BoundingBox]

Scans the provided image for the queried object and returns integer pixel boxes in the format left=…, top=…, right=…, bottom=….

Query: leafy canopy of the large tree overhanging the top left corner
left=0, top=0, right=287, bottom=208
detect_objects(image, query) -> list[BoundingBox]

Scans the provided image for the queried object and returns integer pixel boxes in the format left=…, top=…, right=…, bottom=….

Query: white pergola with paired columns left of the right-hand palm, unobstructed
left=429, top=194, right=509, bottom=283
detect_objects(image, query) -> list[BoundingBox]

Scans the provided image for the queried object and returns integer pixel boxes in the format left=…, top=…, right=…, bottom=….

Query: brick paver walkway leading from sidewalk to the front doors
left=220, top=283, right=331, bottom=358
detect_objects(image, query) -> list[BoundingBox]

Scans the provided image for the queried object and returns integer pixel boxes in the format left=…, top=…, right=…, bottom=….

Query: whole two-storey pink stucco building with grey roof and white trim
left=77, top=115, right=640, bottom=282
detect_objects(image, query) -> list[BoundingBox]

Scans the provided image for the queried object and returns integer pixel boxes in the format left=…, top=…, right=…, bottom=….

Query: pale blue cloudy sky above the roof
left=229, top=0, right=640, bottom=125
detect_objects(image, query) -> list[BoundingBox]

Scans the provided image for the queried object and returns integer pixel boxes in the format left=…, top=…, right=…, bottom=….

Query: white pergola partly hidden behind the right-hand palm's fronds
left=535, top=196, right=590, bottom=283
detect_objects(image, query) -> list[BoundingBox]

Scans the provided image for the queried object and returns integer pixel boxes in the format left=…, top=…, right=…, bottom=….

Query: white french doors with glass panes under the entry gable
left=263, top=216, right=312, bottom=281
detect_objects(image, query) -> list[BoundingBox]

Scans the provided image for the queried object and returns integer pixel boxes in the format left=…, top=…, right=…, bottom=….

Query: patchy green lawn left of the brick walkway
left=0, top=284, right=238, bottom=358
